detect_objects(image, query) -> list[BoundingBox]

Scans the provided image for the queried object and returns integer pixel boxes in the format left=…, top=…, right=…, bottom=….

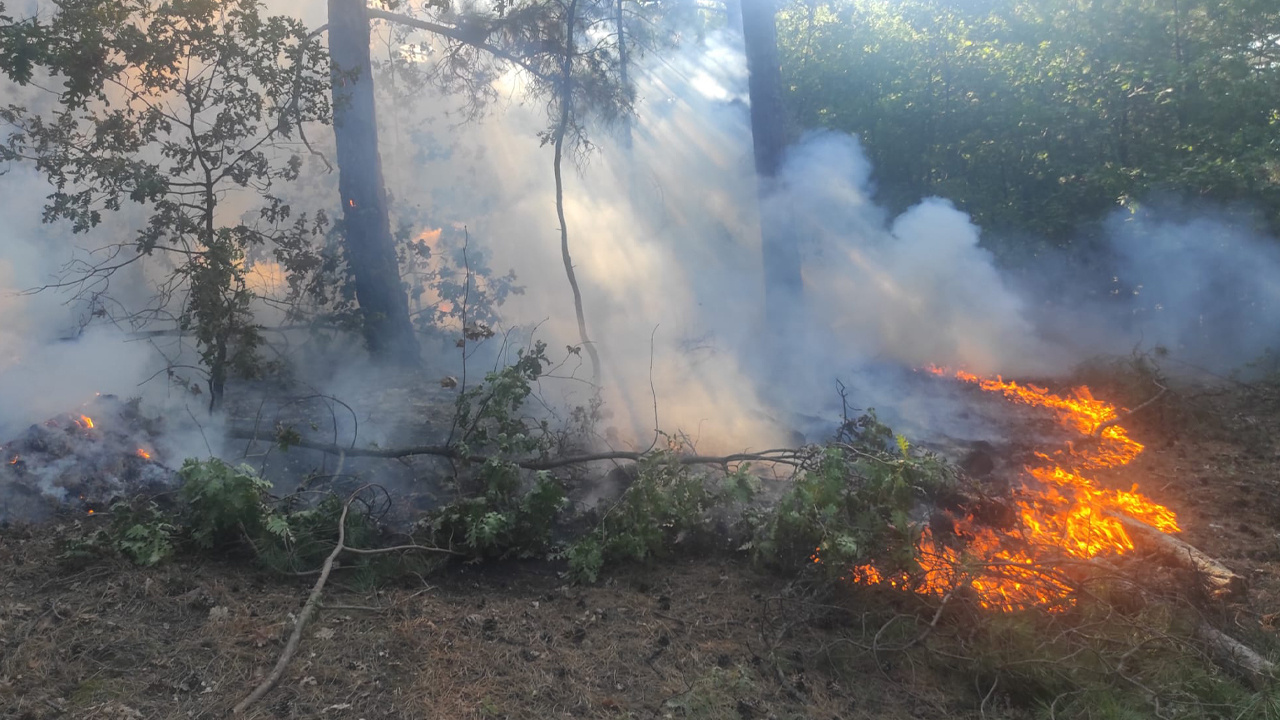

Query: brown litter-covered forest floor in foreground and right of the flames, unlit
left=0, top=371, right=1280, bottom=720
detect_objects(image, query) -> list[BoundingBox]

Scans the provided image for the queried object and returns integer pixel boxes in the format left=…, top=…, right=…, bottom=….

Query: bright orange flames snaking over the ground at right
left=852, top=368, right=1179, bottom=610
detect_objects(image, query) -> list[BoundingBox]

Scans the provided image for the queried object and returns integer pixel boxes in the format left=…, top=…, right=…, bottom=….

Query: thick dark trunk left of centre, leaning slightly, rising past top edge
left=329, top=0, right=419, bottom=363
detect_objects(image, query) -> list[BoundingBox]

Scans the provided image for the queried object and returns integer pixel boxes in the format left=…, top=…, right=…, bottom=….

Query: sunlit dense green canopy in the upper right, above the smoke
left=780, top=0, right=1280, bottom=249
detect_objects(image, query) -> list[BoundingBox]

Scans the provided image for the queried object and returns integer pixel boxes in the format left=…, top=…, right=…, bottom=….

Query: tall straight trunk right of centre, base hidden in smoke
left=741, top=0, right=801, bottom=320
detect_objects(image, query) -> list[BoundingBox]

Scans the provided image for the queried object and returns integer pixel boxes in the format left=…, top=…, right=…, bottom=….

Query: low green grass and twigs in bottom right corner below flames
left=920, top=594, right=1280, bottom=720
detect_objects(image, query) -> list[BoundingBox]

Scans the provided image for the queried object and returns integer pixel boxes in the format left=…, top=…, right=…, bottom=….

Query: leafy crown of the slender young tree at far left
left=0, top=0, right=330, bottom=405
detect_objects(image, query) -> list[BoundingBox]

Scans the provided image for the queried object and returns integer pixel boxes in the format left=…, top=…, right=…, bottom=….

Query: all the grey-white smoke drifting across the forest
left=0, top=12, right=1280, bottom=471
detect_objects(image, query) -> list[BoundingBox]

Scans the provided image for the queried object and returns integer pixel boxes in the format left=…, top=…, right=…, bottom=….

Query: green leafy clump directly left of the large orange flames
left=751, top=410, right=951, bottom=577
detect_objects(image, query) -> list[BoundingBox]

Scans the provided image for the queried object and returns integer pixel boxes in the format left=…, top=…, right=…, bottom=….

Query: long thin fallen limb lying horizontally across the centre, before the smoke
left=228, top=428, right=808, bottom=470
